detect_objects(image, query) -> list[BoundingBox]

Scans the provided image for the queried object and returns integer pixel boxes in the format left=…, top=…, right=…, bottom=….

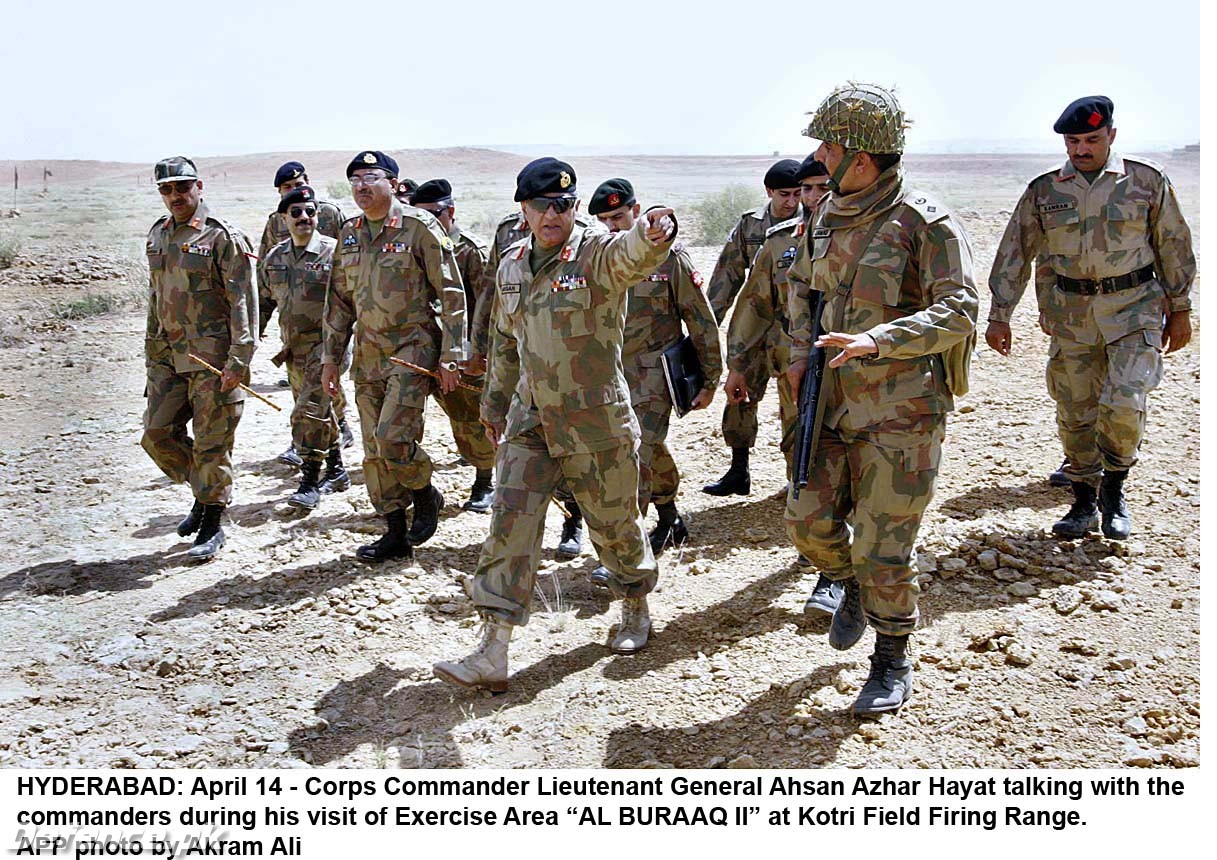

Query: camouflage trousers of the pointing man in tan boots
left=472, top=429, right=660, bottom=624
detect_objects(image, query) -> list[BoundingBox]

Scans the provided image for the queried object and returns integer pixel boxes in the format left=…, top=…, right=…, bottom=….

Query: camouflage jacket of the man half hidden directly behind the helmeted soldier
left=727, top=215, right=807, bottom=375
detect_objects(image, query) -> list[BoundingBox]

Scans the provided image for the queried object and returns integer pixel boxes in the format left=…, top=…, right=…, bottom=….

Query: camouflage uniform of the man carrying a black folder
left=622, top=243, right=723, bottom=513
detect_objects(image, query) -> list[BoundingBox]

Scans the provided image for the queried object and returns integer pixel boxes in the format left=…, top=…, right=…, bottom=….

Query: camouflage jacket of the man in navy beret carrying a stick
left=324, top=199, right=465, bottom=382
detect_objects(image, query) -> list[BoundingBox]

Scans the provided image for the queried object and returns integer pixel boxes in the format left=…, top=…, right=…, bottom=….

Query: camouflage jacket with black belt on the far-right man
left=989, top=151, right=1196, bottom=342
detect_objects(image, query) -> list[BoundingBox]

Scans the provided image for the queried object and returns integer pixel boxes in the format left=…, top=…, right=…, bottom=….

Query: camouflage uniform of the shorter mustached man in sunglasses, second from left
left=258, top=231, right=346, bottom=460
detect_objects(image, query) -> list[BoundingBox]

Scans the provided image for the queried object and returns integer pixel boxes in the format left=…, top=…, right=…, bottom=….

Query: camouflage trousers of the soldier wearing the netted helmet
left=786, top=415, right=946, bottom=636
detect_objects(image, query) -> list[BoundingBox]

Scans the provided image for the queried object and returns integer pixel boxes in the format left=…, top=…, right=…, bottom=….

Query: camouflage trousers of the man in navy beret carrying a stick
left=355, top=373, right=432, bottom=513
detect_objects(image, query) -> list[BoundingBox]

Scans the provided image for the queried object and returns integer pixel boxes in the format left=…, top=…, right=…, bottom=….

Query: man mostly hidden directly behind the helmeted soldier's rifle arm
left=723, top=156, right=829, bottom=479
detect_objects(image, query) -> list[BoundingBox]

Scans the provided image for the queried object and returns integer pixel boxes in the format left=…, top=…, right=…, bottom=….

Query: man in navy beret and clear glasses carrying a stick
left=321, top=151, right=465, bottom=561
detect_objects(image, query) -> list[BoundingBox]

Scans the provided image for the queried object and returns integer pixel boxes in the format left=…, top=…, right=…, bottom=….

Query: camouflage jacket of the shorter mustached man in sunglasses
left=258, top=231, right=338, bottom=365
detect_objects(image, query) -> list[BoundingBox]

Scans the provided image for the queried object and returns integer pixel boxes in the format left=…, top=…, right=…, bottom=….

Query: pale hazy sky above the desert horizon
left=0, top=0, right=1202, bottom=162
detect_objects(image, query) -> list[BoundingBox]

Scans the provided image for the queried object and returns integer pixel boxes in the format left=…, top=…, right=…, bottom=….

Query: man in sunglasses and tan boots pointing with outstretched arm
left=434, top=158, right=675, bottom=691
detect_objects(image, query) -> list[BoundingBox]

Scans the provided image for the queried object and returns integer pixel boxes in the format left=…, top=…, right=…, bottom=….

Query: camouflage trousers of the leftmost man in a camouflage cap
left=140, top=347, right=245, bottom=505
